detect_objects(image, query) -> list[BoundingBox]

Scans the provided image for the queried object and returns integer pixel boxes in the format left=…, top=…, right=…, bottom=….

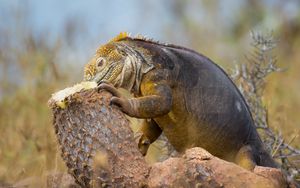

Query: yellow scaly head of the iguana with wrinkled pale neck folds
left=84, top=33, right=153, bottom=90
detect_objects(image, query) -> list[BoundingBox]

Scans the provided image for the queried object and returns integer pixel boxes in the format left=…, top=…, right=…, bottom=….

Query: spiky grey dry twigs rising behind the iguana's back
left=231, top=32, right=300, bottom=179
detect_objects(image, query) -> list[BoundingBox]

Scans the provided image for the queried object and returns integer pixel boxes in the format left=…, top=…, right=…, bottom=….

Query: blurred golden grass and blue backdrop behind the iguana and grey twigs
left=0, top=0, right=300, bottom=185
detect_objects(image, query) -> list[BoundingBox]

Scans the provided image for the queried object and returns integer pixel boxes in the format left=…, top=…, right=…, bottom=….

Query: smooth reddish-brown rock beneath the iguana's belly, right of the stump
left=148, top=148, right=288, bottom=188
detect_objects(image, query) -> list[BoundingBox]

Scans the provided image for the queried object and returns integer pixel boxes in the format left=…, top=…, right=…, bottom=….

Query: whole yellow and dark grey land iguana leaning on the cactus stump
left=84, top=33, right=277, bottom=170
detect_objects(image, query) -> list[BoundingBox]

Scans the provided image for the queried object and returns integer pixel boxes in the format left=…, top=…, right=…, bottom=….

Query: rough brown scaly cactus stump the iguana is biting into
left=49, top=87, right=148, bottom=187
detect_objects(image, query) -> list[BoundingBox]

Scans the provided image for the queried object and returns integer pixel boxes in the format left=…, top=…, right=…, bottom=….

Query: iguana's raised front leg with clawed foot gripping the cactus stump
left=99, top=74, right=172, bottom=118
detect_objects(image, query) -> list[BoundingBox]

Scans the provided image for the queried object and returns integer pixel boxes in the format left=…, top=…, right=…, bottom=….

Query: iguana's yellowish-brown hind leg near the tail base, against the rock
left=235, top=145, right=257, bottom=171
